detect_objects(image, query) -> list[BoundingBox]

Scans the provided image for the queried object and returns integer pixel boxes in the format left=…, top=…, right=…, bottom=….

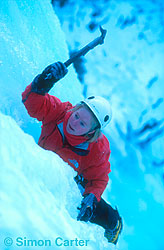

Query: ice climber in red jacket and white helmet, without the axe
left=22, top=62, right=122, bottom=244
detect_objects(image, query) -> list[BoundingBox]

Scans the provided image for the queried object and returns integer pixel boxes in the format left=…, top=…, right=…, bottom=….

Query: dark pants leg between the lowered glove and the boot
left=90, top=198, right=118, bottom=229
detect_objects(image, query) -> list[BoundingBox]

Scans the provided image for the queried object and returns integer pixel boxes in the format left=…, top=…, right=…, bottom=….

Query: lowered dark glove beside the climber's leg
left=77, top=194, right=98, bottom=222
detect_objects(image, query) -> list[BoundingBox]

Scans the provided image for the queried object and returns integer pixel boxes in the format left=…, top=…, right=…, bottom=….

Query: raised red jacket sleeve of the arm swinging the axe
left=22, top=84, right=72, bottom=123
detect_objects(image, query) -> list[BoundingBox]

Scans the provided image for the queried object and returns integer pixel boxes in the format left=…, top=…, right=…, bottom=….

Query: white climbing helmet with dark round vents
left=82, top=96, right=112, bottom=129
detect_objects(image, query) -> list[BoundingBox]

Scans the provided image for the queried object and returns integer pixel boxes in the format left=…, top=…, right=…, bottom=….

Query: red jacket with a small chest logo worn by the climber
left=22, top=84, right=111, bottom=201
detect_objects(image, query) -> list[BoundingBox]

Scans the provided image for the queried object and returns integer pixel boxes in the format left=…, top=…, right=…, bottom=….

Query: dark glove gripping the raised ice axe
left=31, top=62, right=68, bottom=95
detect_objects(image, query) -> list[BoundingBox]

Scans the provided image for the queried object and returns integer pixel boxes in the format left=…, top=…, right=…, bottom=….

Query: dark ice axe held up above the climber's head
left=64, top=26, right=107, bottom=67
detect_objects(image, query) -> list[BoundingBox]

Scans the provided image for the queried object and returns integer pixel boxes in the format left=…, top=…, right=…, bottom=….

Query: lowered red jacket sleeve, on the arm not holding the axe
left=83, top=138, right=111, bottom=201
